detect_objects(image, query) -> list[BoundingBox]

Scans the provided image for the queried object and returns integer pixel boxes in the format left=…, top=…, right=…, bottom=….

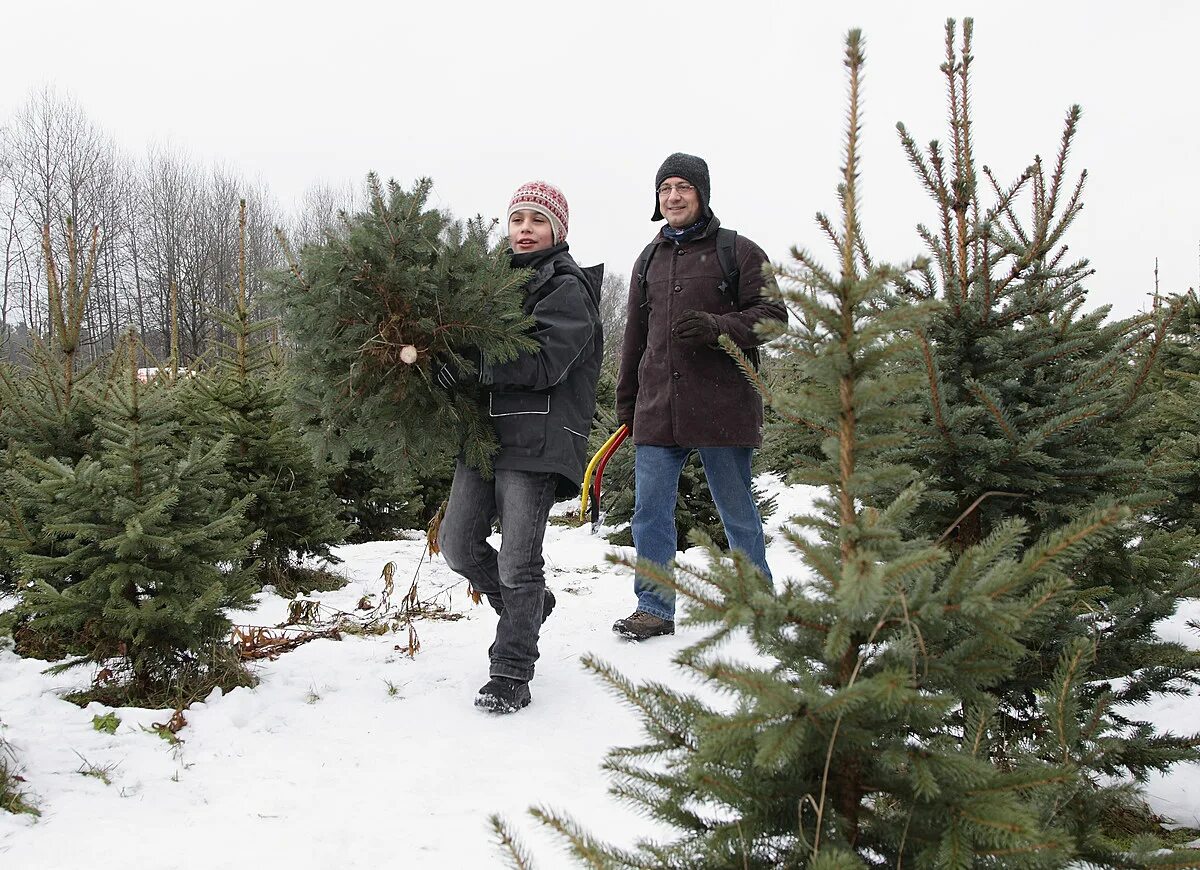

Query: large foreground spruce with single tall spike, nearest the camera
left=518, top=31, right=1200, bottom=869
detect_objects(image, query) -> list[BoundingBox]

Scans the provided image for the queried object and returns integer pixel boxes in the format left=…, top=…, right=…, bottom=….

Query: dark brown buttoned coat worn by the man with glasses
left=617, top=217, right=787, bottom=448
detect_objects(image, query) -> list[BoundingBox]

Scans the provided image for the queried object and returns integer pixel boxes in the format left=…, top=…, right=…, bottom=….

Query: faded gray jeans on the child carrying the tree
left=438, top=460, right=558, bottom=680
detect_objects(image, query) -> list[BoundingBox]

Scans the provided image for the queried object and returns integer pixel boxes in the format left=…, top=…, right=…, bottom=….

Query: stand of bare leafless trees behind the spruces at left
left=0, top=88, right=362, bottom=362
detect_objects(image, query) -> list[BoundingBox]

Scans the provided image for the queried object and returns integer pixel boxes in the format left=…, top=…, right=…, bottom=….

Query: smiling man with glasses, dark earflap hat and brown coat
left=612, top=154, right=787, bottom=641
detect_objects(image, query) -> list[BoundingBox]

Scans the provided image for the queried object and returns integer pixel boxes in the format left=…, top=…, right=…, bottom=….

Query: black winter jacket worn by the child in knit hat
left=480, top=242, right=604, bottom=498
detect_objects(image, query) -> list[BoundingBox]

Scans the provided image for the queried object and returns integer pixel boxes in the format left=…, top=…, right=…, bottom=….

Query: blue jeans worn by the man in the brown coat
left=632, top=445, right=770, bottom=619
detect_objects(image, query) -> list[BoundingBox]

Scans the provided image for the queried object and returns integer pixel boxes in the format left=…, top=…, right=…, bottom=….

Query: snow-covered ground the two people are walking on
left=0, top=480, right=1200, bottom=870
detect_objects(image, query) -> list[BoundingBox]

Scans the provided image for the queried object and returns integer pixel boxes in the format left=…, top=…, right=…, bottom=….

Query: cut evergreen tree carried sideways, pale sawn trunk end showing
left=274, top=175, right=535, bottom=478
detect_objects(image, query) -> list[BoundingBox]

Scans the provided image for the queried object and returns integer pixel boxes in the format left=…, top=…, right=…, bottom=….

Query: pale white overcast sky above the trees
left=0, top=0, right=1200, bottom=313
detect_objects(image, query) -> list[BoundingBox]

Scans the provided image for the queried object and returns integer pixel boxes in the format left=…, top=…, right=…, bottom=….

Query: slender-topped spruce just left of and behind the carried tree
left=176, top=200, right=349, bottom=588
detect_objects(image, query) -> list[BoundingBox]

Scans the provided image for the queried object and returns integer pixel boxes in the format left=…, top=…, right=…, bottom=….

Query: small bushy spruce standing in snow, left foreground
left=11, top=336, right=253, bottom=697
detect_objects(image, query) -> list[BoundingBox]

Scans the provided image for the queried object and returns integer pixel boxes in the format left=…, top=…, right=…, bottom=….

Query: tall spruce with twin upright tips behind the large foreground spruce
left=899, top=20, right=1200, bottom=832
